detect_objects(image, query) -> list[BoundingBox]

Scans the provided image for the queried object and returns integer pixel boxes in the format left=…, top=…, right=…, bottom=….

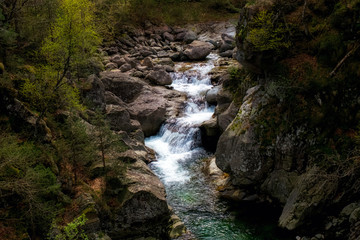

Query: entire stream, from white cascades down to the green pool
left=145, top=54, right=288, bottom=240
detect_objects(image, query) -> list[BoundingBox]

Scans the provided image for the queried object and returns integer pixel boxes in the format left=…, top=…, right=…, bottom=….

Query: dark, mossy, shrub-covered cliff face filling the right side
left=216, top=1, right=360, bottom=239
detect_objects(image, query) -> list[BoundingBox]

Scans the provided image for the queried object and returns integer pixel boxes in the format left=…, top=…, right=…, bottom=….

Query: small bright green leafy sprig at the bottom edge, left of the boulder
left=54, top=214, right=89, bottom=240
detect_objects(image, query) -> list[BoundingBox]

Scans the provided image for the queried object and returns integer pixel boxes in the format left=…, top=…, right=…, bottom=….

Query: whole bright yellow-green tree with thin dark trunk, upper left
left=24, top=0, right=100, bottom=129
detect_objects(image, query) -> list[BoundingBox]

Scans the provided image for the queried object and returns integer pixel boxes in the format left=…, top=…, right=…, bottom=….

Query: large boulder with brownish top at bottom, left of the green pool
left=107, top=160, right=171, bottom=239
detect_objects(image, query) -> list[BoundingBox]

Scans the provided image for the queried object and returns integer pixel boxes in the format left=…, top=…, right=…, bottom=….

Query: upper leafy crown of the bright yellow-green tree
left=41, top=0, right=100, bottom=76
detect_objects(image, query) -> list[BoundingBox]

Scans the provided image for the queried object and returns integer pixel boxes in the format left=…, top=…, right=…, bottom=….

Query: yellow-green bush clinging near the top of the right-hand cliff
left=246, top=10, right=290, bottom=52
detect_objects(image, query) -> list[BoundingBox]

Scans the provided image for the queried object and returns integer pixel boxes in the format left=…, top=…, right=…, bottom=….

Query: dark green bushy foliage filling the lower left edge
left=0, top=132, right=61, bottom=232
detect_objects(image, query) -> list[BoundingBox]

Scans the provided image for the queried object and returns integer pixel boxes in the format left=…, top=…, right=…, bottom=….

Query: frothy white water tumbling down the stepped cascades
left=145, top=54, right=217, bottom=184
